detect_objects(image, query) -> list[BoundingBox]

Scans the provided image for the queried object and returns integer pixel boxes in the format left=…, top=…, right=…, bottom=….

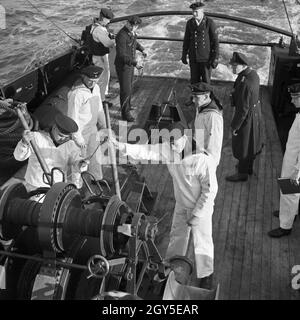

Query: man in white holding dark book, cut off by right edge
left=268, top=83, right=300, bottom=238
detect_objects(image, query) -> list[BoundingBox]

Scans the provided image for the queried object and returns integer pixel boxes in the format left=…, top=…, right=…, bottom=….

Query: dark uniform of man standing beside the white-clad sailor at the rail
left=115, top=26, right=144, bottom=120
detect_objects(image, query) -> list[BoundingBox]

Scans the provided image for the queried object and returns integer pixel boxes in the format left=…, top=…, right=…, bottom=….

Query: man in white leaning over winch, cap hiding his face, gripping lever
left=14, top=113, right=84, bottom=191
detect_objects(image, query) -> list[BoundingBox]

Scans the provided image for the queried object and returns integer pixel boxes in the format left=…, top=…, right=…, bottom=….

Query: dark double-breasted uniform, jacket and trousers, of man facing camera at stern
left=182, top=16, right=219, bottom=84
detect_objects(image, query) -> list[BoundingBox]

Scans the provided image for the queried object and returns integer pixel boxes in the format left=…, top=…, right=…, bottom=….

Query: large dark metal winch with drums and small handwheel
left=0, top=182, right=164, bottom=300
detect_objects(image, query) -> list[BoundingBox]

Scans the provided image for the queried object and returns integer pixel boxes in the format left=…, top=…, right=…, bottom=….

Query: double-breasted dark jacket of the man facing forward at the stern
left=182, top=16, right=219, bottom=63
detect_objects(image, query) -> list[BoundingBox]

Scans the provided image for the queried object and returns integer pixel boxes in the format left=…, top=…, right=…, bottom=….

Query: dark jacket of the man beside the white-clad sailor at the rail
left=115, top=26, right=144, bottom=66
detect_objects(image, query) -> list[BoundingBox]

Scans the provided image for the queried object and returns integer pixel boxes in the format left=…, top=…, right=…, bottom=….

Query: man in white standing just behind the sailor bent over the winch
left=68, top=66, right=106, bottom=180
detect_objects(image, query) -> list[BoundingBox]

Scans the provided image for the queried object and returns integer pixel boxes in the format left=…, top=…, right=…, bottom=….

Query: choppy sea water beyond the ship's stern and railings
left=0, top=0, right=300, bottom=84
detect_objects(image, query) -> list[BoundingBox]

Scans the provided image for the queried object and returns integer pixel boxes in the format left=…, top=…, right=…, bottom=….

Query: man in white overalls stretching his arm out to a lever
left=112, top=122, right=218, bottom=289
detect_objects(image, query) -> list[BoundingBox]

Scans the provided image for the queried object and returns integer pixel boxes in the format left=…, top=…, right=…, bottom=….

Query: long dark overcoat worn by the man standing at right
left=231, top=68, right=262, bottom=160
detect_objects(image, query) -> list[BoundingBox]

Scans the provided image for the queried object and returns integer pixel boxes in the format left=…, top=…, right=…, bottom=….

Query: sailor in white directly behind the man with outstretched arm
left=191, top=82, right=223, bottom=166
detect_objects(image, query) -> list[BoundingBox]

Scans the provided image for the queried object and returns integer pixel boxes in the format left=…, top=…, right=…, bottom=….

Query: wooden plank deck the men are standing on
left=105, top=77, right=300, bottom=300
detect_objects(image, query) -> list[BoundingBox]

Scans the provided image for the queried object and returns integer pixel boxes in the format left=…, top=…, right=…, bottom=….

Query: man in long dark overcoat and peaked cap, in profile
left=226, top=52, right=263, bottom=182
